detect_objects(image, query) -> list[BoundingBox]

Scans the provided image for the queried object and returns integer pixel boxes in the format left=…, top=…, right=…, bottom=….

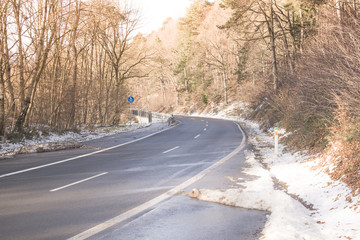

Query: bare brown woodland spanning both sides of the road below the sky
left=0, top=0, right=360, bottom=191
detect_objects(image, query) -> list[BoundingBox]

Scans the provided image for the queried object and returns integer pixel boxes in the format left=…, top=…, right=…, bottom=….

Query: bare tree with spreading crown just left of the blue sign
left=99, top=1, right=148, bottom=124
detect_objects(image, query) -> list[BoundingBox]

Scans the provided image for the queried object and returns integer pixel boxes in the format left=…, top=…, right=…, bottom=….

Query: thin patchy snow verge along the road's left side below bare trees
left=0, top=117, right=168, bottom=159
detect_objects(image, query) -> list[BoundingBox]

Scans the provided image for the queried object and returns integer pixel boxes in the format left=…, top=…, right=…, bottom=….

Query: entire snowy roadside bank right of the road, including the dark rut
left=189, top=104, right=360, bottom=240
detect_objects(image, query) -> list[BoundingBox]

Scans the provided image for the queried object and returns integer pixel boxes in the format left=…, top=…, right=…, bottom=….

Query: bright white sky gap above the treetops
left=130, top=0, right=191, bottom=34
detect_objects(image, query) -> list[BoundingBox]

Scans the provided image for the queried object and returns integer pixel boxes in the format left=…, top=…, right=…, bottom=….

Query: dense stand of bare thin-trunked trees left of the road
left=0, top=0, right=148, bottom=135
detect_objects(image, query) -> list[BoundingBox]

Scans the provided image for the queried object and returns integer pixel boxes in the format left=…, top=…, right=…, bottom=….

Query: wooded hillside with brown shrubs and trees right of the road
left=133, top=0, right=360, bottom=194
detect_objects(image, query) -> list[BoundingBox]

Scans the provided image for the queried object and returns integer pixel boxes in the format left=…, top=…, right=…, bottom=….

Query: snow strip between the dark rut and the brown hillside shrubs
left=250, top=123, right=360, bottom=239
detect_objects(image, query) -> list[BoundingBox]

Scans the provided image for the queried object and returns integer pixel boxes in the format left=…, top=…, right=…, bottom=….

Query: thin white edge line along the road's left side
left=0, top=125, right=177, bottom=178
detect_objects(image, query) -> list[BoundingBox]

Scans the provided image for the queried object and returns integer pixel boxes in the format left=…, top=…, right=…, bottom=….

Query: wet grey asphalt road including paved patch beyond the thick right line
left=0, top=117, right=266, bottom=240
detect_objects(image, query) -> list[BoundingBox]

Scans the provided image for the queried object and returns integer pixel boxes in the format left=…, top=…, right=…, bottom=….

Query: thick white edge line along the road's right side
left=68, top=123, right=246, bottom=240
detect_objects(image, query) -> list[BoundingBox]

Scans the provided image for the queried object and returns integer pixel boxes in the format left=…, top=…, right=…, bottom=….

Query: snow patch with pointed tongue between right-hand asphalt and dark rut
left=190, top=152, right=329, bottom=240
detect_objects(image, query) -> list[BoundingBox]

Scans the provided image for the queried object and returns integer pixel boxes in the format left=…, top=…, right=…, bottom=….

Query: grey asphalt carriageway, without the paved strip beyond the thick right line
left=0, top=117, right=264, bottom=240
